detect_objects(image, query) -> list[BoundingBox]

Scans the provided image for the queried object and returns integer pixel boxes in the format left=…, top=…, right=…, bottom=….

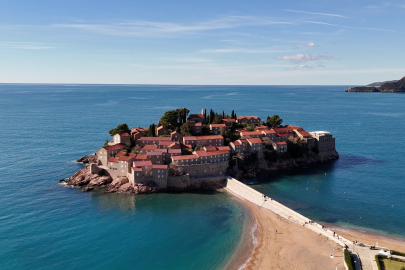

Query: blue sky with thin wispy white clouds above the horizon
left=0, top=0, right=405, bottom=85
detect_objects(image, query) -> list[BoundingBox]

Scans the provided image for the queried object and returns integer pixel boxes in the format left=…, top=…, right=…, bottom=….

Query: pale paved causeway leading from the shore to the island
left=227, top=177, right=392, bottom=270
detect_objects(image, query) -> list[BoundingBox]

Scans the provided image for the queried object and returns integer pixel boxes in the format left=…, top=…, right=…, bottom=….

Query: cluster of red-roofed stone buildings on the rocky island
left=97, top=111, right=335, bottom=188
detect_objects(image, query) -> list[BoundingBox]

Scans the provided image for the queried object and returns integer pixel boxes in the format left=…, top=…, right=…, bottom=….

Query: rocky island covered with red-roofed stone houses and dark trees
left=60, top=108, right=339, bottom=193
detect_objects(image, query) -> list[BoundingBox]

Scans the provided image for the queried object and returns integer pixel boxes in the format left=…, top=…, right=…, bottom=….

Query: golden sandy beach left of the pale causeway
left=241, top=199, right=345, bottom=270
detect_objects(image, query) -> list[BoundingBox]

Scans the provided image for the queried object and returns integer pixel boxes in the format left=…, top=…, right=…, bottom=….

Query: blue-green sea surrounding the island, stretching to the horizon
left=0, top=84, right=405, bottom=270
